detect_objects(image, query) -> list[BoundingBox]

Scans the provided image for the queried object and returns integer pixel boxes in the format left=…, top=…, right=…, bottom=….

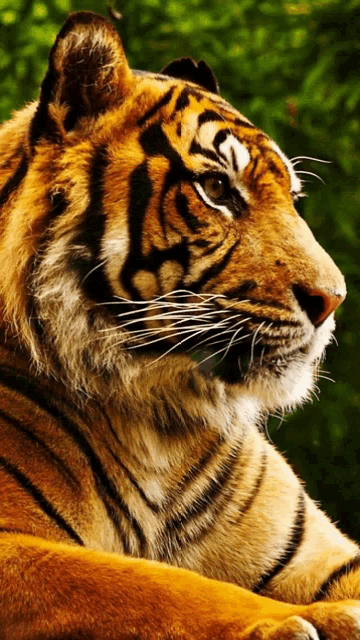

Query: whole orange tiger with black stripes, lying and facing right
left=0, top=11, right=360, bottom=640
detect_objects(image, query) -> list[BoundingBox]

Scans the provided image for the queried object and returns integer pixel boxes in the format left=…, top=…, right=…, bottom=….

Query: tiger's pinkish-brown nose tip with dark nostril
left=293, top=284, right=346, bottom=327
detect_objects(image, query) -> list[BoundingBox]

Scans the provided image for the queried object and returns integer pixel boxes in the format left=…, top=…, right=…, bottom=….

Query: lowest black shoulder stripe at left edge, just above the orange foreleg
left=0, top=456, right=84, bottom=546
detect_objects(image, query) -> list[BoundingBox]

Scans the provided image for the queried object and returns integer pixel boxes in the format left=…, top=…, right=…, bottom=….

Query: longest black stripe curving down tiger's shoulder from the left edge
left=0, top=366, right=145, bottom=552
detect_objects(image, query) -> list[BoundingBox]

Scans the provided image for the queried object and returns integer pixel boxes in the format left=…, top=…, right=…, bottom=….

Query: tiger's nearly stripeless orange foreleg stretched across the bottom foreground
left=0, top=534, right=360, bottom=640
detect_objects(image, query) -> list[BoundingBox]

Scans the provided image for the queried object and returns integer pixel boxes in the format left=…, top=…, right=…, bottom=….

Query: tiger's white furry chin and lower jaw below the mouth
left=193, top=316, right=335, bottom=411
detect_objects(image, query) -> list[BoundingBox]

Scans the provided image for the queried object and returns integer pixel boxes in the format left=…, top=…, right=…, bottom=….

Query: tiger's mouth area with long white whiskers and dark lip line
left=109, top=290, right=333, bottom=386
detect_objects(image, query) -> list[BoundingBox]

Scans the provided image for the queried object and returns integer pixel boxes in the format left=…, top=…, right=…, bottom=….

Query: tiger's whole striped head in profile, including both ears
left=0, top=12, right=345, bottom=416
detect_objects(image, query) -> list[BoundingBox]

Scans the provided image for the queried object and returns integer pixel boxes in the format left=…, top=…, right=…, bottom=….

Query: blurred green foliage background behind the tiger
left=0, top=0, right=360, bottom=541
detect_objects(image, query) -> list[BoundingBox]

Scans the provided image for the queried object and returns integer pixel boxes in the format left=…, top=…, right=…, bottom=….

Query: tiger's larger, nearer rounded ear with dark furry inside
left=30, top=11, right=131, bottom=147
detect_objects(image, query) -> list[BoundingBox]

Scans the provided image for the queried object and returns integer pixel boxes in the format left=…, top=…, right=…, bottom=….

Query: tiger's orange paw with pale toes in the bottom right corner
left=239, top=601, right=360, bottom=640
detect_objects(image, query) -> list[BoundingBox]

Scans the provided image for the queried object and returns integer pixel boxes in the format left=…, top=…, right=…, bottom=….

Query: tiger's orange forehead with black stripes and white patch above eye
left=131, top=72, right=301, bottom=194
